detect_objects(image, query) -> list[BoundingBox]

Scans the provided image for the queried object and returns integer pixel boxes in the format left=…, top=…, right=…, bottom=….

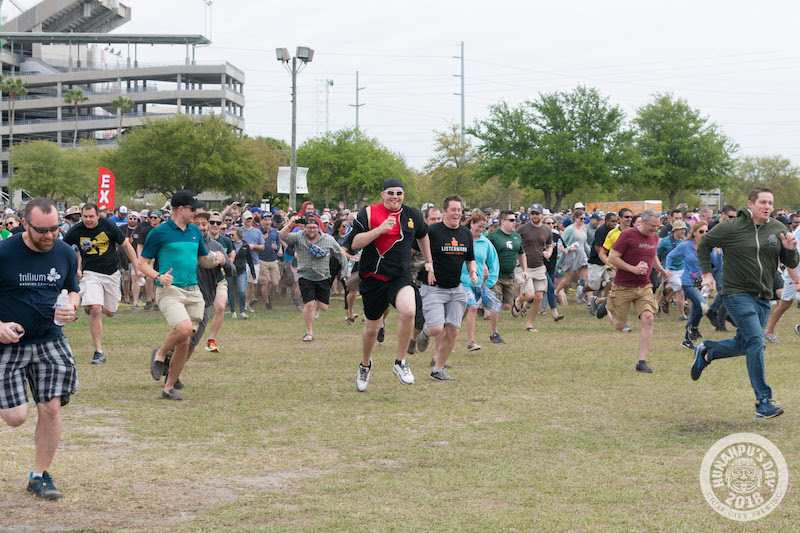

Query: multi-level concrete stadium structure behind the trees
left=0, top=0, right=245, bottom=205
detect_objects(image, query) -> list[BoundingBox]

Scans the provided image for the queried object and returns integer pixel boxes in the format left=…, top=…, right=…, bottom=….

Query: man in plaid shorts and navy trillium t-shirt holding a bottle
left=0, top=197, right=80, bottom=500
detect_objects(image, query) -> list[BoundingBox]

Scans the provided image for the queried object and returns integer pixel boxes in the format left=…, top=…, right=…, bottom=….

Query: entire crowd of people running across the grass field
left=0, top=183, right=800, bottom=499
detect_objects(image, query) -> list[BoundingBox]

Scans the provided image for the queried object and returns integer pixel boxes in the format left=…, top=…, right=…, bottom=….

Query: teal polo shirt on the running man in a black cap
left=142, top=219, right=208, bottom=287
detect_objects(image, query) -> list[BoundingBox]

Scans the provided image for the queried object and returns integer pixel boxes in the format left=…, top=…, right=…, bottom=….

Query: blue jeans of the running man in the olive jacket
left=704, top=293, right=772, bottom=401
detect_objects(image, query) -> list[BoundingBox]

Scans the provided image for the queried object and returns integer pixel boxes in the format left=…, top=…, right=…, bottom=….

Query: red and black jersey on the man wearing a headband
left=348, top=203, right=428, bottom=279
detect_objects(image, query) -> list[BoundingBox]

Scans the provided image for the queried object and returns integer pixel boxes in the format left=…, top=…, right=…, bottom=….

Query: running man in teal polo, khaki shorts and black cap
left=139, top=190, right=225, bottom=400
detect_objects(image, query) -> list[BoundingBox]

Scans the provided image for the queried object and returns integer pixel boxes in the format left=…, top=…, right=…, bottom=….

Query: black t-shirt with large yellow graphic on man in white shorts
left=64, top=217, right=125, bottom=275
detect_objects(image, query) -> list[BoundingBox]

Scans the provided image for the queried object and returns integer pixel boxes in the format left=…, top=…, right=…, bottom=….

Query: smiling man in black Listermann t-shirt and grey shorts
left=417, top=194, right=478, bottom=381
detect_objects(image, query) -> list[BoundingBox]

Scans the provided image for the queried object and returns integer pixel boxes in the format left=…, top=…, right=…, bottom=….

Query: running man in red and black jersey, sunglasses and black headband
left=351, top=178, right=433, bottom=392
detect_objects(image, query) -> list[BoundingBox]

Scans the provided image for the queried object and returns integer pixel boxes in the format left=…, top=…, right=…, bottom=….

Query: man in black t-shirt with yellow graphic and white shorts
left=64, top=203, right=139, bottom=365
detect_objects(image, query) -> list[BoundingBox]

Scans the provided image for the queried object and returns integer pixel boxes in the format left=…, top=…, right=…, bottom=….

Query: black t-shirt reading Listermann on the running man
left=418, top=222, right=475, bottom=289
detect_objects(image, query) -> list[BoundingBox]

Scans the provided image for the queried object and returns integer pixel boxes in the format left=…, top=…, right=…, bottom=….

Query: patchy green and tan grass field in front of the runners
left=0, top=299, right=800, bottom=531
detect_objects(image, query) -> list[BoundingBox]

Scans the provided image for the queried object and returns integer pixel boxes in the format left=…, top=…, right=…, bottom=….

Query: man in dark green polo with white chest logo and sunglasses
left=486, top=210, right=535, bottom=344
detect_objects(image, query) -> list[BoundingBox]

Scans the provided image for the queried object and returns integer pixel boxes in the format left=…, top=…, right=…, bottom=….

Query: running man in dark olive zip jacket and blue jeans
left=691, top=187, right=800, bottom=418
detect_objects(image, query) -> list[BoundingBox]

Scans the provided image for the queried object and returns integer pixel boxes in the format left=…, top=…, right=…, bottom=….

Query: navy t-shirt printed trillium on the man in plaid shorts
left=0, top=234, right=80, bottom=344
